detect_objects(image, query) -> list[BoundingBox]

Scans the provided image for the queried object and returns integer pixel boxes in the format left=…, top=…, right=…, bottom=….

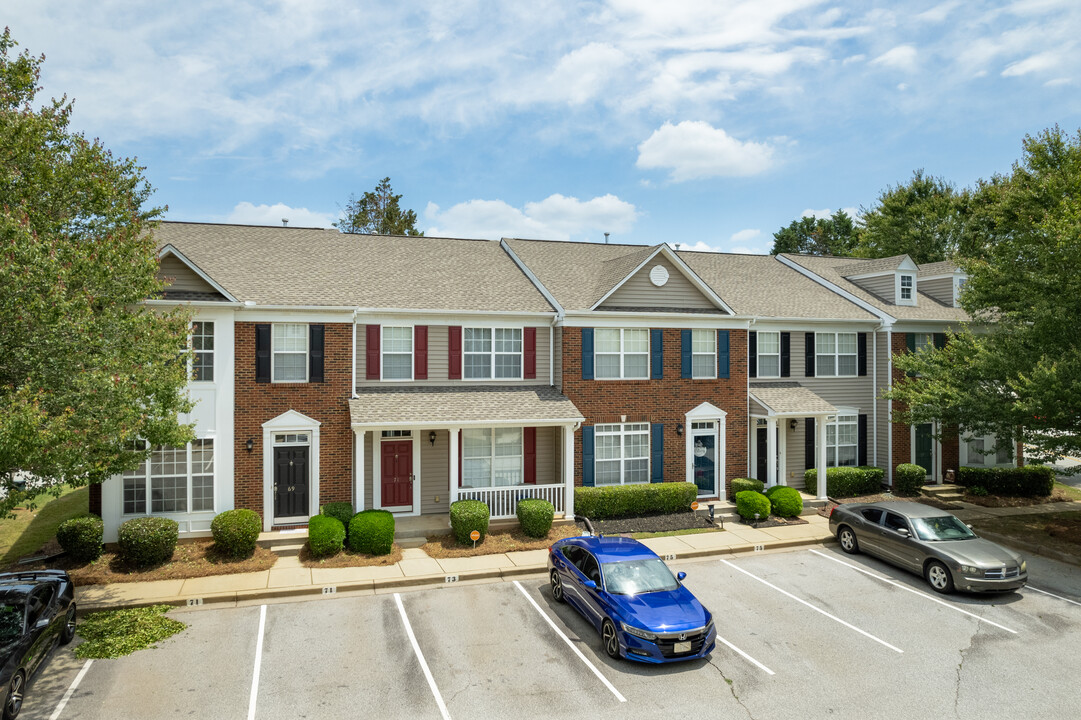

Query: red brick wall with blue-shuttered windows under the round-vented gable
left=562, top=328, right=748, bottom=497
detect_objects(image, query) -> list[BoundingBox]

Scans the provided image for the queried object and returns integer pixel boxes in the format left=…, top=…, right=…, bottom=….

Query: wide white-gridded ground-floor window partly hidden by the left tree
left=123, top=438, right=214, bottom=515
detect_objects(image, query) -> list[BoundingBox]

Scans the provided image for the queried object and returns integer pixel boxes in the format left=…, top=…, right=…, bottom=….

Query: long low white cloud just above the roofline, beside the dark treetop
left=424, top=194, right=638, bottom=240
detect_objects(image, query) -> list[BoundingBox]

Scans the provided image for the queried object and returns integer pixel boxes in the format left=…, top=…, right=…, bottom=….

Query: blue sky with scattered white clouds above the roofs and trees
left=3, top=0, right=1081, bottom=252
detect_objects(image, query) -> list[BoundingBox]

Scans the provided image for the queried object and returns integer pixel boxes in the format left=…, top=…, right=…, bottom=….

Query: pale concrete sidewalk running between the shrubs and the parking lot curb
left=76, top=515, right=832, bottom=614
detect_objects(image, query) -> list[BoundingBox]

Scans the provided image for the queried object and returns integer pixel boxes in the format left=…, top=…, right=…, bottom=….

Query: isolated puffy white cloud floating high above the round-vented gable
left=636, top=120, right=774, bottom=183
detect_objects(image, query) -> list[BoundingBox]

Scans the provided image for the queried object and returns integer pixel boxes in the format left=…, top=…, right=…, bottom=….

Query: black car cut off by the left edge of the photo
left=0, top=570, right=75, bottom=720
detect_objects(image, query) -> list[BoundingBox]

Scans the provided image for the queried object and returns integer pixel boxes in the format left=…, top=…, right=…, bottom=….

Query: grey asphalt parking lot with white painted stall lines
left=24, top=547, right=1081, bottom=720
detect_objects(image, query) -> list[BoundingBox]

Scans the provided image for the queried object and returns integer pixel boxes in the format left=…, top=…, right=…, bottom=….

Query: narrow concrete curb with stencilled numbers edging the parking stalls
left=76, top=537, right=837, bottom=616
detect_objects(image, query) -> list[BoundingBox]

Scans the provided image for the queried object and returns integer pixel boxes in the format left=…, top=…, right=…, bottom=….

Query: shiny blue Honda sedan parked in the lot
left=548, top=536, right=717, bottom=663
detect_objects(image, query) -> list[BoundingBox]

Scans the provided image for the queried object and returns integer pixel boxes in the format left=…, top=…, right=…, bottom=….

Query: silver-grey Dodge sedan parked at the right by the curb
left=829, top=502, right=1028, bottom=592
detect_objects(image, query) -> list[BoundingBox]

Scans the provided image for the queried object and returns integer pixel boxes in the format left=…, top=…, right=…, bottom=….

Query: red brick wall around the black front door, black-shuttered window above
left=233, top=322, right=352, bottom=517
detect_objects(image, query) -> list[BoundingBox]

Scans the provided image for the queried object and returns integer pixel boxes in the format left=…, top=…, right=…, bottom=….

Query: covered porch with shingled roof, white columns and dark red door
left=349, top=385, right=584, bottom=520
